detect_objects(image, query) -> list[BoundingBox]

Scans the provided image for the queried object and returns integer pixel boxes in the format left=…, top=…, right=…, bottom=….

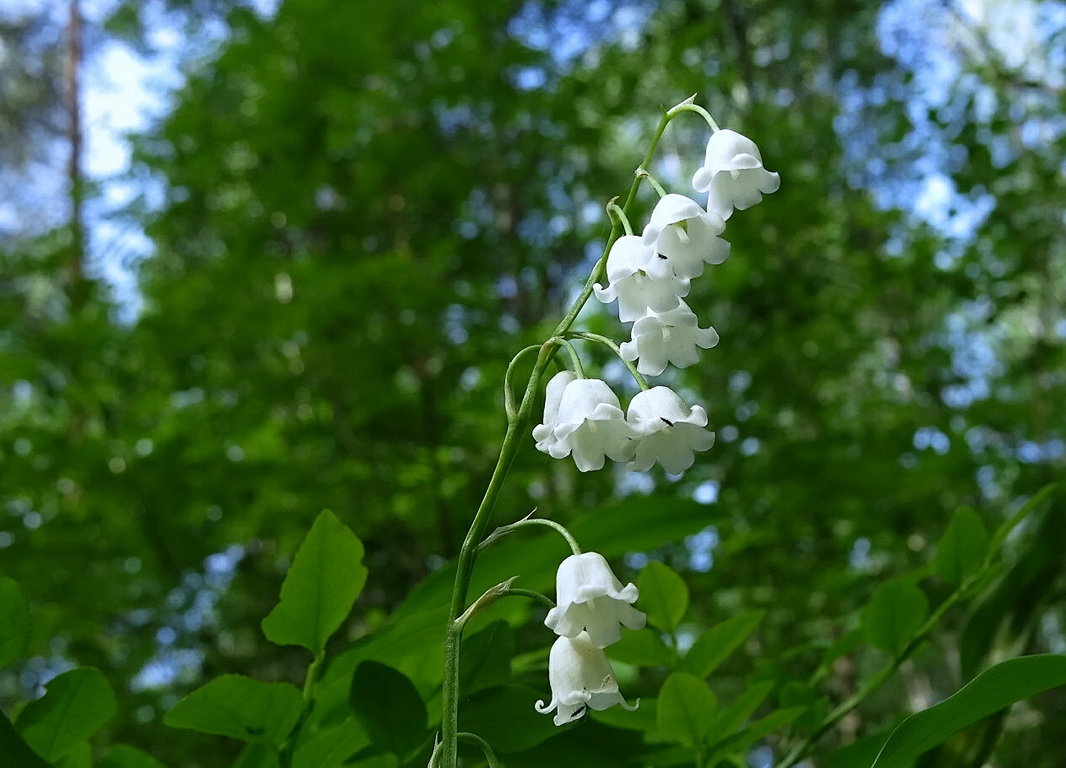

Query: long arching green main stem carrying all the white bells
left=439, top=108, right=678, bottom=768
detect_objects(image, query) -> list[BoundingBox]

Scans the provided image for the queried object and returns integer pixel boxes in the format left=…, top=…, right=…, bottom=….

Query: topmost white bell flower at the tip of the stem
left=692, top=128, right=781, bottom=219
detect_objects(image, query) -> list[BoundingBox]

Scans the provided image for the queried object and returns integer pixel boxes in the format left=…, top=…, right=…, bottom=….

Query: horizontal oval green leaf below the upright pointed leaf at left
left=163, top=674, right=304, bottom=745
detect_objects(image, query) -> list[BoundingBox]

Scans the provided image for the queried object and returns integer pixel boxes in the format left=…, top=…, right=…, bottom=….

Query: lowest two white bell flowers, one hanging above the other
left=535, top=553, right=646, bottom=725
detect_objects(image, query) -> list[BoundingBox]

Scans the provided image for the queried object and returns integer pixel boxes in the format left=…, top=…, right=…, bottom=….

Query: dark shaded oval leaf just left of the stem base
left=349, top=661, right=429, bottom=758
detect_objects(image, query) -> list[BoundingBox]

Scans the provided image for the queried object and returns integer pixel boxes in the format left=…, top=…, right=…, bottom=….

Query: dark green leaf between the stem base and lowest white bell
left=459, top=681, right=562, bottom=753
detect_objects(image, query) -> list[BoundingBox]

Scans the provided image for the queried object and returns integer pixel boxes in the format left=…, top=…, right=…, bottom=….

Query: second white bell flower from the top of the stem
left=642, top=193, right=729, bottom=278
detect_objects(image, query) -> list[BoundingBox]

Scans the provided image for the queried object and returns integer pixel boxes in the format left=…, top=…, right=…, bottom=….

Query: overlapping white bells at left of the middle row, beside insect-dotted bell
left=533, top=379, right=633, bottom=471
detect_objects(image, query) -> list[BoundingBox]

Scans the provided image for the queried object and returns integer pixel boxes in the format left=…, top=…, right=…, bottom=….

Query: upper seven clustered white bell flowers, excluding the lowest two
left=533, top=129, right=780, bottom=475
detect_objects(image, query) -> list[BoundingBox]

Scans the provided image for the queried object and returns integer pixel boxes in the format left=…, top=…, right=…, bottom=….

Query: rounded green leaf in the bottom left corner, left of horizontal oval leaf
left=15, top=667, right=118, bottom=762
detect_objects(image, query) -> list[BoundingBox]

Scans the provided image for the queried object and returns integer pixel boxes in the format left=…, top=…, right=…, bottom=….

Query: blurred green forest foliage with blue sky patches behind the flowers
left=0, top=0, right=1066, bottom=768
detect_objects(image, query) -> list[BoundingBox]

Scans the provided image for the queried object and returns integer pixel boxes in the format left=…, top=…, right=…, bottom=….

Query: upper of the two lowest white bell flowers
left=544, top=553, right=647, bottom=647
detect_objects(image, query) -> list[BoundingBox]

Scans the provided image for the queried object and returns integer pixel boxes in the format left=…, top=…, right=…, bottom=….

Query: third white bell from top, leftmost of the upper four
left=593, top=235, right=689, bottom=322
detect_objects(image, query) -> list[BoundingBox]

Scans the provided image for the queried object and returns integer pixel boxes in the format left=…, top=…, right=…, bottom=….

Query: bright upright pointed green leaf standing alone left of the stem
left=262, top=510, right=367, bottom=656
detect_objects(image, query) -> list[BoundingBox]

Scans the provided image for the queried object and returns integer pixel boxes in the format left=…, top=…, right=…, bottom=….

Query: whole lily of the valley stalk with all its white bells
left=430, top=98, right=780, bottom=768
